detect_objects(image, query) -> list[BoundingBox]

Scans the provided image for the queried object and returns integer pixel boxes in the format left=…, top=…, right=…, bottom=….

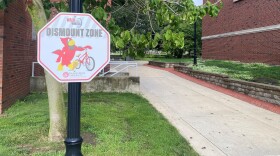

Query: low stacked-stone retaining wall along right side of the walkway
left=174, top=66, right=280, bottom=105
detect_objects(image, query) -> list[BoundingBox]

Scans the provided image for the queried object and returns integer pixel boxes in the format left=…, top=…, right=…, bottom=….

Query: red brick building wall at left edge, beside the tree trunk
left=0, top=0, right=36, bottom=114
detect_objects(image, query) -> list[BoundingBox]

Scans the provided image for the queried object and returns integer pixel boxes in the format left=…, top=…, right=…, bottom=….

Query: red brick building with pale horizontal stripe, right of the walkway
left=202, top=0, right=280, bottom=65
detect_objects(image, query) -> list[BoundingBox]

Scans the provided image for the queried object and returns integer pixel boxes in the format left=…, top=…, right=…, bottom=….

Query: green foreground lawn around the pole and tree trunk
left=0, top=93, right=197, bottom=156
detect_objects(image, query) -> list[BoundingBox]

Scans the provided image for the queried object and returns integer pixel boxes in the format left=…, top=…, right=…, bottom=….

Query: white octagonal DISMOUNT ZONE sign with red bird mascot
left=37, top=13, right=110, bottom=82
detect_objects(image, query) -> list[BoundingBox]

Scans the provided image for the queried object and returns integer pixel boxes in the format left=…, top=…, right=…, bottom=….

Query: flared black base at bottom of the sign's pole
left=64, top=137, right=83, bottom=156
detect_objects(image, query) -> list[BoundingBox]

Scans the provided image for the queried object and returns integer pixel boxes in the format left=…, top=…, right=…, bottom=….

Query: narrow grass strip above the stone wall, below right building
left=143, top=58, right=280, bottom=85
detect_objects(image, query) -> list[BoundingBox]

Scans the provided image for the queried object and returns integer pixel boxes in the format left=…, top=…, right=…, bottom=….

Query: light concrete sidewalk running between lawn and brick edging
left=132, top=63, right=280, bottom=156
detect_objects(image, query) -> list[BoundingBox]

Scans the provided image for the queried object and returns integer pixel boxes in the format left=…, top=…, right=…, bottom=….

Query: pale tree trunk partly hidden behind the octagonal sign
left=28, top=0, right=66, bottom=141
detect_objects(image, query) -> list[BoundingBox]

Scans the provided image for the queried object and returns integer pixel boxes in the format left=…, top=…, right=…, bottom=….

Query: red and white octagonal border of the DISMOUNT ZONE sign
left=37, top=12, right=111, bottom=83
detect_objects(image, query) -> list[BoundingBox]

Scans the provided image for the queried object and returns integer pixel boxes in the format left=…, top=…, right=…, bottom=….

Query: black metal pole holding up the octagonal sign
left=64, top=0, right=83, bottom=156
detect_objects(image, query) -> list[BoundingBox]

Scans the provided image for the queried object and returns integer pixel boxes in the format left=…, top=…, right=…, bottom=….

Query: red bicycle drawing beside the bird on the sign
left=76, top=50, right=95, bottom=71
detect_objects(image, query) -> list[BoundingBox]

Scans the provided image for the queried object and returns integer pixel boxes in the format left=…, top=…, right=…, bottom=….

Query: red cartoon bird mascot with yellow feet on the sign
left=53, top=37, right=92, bottom=71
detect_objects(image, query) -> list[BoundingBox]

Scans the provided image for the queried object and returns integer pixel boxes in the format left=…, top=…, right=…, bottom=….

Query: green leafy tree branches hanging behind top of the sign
left=0, top=0, right=222, bottom=56
